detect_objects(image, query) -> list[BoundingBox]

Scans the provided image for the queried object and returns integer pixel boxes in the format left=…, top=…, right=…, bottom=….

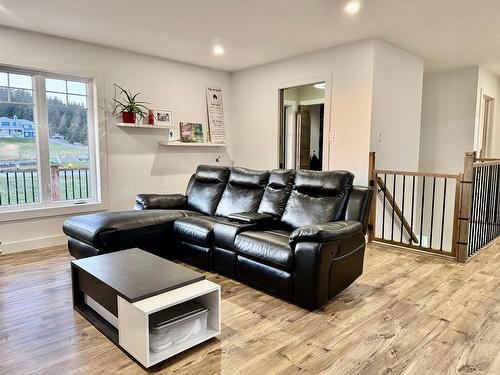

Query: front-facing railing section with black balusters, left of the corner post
left=370, top=153, right=459, bottom=257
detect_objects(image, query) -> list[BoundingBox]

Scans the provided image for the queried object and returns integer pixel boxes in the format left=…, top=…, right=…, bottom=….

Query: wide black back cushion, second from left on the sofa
left=215, top=167, right=269, bottom=217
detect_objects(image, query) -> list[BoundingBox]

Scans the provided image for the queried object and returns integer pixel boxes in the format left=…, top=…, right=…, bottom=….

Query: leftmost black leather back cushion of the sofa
left=186, top=165, right=229, bottom=215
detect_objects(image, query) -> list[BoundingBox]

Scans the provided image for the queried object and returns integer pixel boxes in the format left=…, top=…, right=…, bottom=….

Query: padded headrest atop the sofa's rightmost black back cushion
left=293, top=170, right=354, bottom=196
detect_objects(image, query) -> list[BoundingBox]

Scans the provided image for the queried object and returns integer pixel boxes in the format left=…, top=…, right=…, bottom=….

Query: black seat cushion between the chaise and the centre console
left=174, top=216, right=228, bottom=246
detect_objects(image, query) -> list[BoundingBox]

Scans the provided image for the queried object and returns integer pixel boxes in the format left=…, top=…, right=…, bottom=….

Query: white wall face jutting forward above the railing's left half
left=370, top=40, right=424, bottom=171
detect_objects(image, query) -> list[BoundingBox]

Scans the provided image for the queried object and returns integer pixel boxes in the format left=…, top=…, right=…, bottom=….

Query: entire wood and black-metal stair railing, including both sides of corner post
left=368, top=152, right=500, bottom=263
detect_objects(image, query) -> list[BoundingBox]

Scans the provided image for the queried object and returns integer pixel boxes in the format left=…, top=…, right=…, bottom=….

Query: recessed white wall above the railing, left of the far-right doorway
left=419, top=67, right=478, bottom=173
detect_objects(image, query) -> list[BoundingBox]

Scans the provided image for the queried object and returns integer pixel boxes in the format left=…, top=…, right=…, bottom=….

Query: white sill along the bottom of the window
left=0, top=202, right=108, bottom=223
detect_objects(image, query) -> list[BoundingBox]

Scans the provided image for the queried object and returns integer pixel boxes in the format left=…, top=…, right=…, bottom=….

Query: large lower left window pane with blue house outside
left=0, top=102, right=40, bottom=206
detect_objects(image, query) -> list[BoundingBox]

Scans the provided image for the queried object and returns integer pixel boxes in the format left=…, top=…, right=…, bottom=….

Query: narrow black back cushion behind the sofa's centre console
left=258, top=169, right=295, bottom=216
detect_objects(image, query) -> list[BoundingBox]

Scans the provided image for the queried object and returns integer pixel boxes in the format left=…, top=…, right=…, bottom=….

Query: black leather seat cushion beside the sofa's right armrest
left=234, top=230, right=293, bottom=271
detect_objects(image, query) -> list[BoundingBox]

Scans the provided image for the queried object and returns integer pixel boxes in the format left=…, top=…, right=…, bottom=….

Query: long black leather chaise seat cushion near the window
left=63, top=210, right=199, bottom=250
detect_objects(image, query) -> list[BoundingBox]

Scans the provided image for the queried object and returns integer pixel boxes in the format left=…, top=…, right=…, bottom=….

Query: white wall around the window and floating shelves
left=0, top=27, right=231, bottom=252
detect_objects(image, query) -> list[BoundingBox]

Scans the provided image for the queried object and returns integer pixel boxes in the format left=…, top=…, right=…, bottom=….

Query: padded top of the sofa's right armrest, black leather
left=289, top=220, right=363, bottom=244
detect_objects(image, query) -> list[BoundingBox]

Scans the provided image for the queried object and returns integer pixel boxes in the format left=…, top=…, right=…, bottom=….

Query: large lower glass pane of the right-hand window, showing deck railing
left=47, top=96, right=92, bottom=201
